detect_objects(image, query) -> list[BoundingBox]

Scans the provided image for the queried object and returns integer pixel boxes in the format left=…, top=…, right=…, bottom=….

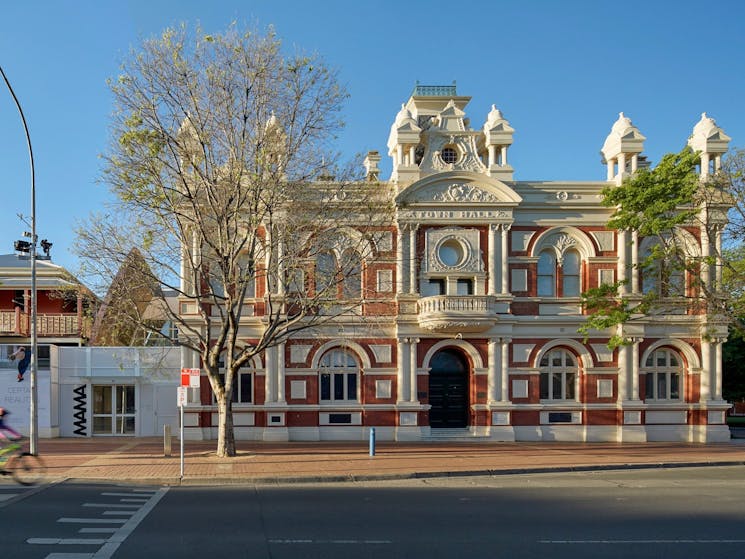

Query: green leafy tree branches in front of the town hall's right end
left=579, top=148, right=736, bottom=347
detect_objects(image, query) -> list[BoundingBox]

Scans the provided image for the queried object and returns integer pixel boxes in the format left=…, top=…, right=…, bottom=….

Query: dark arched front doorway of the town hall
left=429, top=349, right=469, bottom=429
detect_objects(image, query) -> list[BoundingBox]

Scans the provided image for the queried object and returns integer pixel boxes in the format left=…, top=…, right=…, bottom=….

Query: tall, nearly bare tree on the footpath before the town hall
left=78, top=26, right=392, bottom=456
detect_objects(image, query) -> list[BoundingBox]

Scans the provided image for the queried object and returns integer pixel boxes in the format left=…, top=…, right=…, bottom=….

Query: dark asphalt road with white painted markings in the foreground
left=0, top=467, right=745, bottom=559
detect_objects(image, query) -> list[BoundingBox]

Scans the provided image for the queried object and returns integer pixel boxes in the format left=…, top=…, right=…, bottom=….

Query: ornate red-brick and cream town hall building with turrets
left=181, top=85, right=730, bottom=442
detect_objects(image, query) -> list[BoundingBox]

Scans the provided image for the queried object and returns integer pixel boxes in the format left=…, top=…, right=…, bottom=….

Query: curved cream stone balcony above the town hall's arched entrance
left=417, top=295, right=497, bottom=333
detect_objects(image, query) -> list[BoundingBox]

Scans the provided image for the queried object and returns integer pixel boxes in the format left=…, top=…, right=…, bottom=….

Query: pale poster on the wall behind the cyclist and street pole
left=0, top=369, right=51, bottom=436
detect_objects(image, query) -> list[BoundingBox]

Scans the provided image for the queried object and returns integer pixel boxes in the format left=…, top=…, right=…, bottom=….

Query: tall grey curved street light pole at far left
left=0, top=66, right=39, bottom=454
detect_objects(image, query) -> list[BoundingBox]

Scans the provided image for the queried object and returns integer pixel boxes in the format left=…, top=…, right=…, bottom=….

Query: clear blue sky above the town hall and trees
left=0, top=0, right=745, bottom=273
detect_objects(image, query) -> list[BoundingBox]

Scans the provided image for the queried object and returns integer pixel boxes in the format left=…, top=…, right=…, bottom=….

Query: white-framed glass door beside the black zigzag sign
left=93, top=384, right=136, bottom=435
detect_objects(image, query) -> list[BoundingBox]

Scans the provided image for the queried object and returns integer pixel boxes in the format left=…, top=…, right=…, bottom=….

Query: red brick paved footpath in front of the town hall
left=26, top=437, right=745, bottom=484
